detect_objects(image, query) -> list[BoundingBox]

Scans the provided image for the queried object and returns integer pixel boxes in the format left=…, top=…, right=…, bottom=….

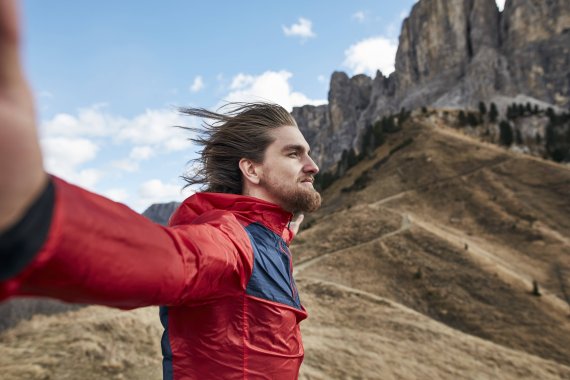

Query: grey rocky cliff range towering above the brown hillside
left=293, top=0, right=570, bottom=170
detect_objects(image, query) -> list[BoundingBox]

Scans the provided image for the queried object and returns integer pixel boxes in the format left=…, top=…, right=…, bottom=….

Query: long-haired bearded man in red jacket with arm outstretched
left=0, top=0, right=321, bottom=379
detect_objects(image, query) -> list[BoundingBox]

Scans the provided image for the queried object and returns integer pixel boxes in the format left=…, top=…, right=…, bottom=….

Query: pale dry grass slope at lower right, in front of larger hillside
left=299, top=279, right=570, bottom=380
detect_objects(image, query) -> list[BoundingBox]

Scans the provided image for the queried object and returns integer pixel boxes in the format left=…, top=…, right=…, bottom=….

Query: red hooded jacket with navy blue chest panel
left=0, top=178, right=307, bottom=380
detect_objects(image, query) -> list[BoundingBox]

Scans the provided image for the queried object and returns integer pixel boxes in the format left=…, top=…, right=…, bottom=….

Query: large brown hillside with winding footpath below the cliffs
left=293, top=117, right=570, bottom=376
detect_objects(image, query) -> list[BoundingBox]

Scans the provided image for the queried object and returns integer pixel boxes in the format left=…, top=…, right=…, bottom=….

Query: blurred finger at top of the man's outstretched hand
left=0, top=0, right=22, bottom=86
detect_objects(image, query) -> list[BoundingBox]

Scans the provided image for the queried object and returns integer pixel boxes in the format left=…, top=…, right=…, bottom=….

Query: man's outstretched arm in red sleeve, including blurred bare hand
left=0, top=0, right=251, bottom=308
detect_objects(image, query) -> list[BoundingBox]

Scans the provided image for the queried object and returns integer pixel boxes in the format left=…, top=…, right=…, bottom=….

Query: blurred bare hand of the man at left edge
left=0, top=0, right=47, bottom=233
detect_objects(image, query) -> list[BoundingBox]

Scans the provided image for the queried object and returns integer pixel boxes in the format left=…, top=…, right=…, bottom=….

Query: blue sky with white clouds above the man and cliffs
left=21, top=0, right=504, bottom=212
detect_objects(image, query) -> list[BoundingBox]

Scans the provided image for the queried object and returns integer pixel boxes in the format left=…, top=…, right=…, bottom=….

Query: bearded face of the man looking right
left=259, top=126, right=321, bottom=212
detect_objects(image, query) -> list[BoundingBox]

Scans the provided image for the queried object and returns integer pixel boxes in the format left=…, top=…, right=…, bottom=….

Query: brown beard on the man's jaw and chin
left=261, top=178, right=321, bottom=213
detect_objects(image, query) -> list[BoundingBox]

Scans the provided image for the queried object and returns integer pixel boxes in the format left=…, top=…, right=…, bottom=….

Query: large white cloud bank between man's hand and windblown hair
left=40, top=105, right=197, bottom=208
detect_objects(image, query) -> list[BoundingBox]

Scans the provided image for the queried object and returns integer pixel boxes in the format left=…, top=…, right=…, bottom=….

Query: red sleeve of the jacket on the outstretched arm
left=0, top=177, right=253, bottom=309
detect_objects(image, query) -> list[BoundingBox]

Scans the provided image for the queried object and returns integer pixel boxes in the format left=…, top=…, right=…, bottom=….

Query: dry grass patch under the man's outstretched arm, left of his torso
left=0, top=306, right=162, bottom=380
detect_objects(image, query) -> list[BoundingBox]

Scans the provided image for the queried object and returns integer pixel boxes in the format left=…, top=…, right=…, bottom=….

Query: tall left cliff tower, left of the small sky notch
left=395, top=0, right=504, bottom=109
